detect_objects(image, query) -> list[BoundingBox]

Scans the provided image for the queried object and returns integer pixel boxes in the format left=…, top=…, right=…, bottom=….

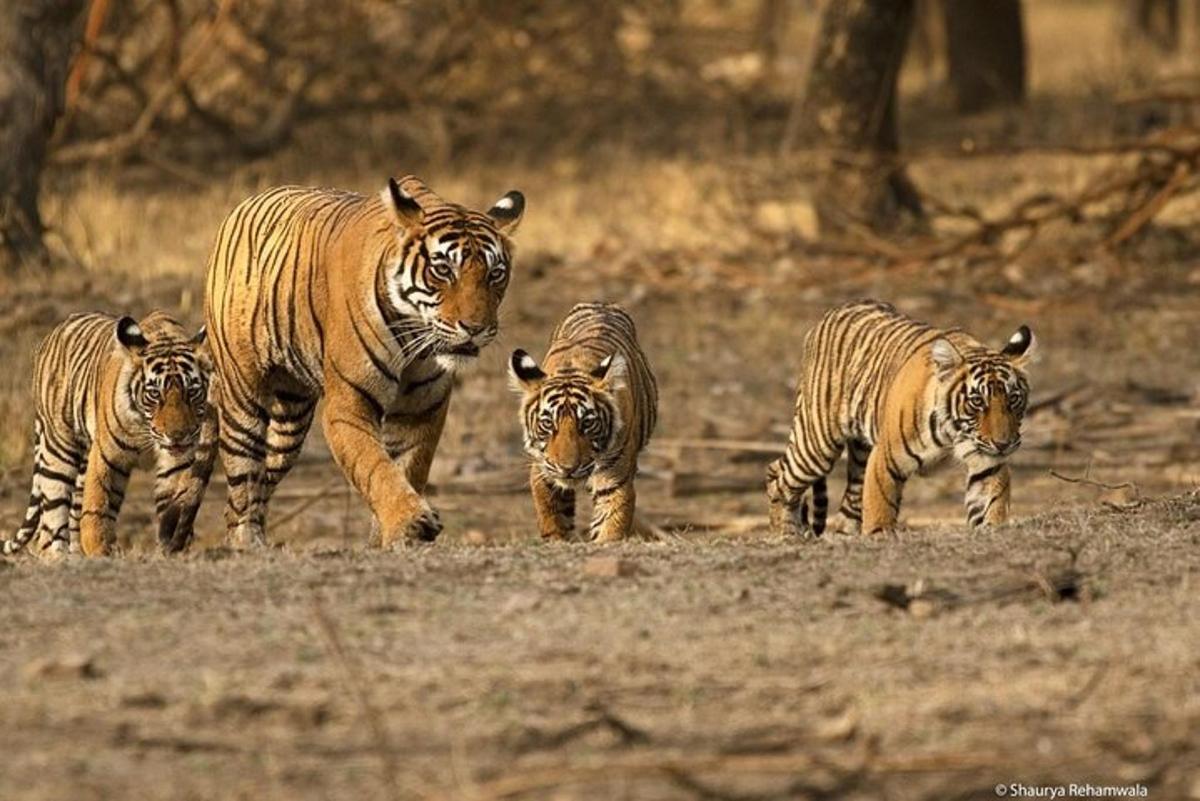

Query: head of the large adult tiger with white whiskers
left=380, top=176, right=524, bottom=368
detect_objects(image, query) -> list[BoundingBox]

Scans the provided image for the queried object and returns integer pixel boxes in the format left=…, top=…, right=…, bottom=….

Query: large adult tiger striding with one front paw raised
left=205, top=176, right=524, bottom=544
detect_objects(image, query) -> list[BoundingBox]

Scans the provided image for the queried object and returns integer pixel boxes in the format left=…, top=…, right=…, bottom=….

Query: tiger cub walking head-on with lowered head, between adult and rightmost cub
left=511, top=303, right=659, bottom=542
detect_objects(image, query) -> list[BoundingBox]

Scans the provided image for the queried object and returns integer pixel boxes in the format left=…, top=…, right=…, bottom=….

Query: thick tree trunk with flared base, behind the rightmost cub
left=799, top=0, right=923, bottom=231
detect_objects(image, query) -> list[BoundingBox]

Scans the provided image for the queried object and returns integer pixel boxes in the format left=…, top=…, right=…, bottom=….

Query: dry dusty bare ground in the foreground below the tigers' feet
left=0, top=498, right=1200, bottom=801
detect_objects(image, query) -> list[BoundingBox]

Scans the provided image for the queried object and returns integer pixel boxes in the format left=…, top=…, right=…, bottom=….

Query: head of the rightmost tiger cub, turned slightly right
left=930, top=325, right=1036, bottom=458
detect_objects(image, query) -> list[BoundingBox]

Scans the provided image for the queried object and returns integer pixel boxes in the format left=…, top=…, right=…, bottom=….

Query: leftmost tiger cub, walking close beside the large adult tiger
left=2, top=312, right=215, bottom=555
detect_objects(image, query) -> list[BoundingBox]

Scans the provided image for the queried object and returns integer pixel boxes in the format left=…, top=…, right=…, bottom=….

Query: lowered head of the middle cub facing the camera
left=509, top=350, right=626, bottom=484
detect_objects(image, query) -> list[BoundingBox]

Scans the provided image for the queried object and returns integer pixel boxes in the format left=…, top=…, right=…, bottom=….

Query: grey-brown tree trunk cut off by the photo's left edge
left=0, top=0, right=86, bottom=270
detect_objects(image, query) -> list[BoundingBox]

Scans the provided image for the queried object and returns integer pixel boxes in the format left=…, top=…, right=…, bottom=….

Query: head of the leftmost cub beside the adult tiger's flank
left=116, top=317, right=212, bottom=454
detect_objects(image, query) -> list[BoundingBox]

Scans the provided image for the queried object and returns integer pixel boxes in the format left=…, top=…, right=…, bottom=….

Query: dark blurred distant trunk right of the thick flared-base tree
left=942, top=0, right=1025, bottom=113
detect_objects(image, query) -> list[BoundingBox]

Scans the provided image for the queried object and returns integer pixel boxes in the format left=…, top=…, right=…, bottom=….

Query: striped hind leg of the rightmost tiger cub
left=767, top=399, right=842, bottom=536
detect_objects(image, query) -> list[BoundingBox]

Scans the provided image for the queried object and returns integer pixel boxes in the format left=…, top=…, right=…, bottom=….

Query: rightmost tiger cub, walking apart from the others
left=767, top=301, right=1034, bottom=535
